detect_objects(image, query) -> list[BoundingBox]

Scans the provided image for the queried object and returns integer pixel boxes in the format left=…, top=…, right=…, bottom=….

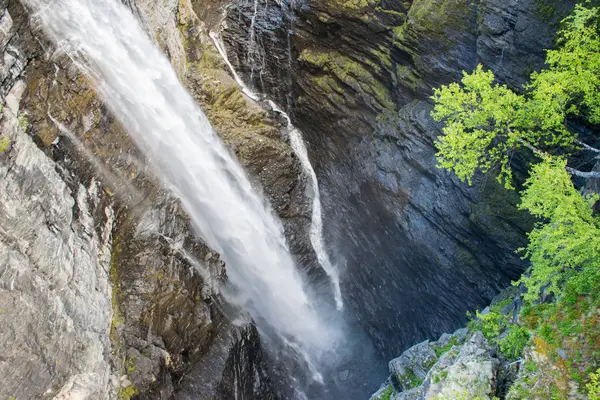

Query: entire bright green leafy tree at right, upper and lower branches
left=432, top=5, right=600, bottom=300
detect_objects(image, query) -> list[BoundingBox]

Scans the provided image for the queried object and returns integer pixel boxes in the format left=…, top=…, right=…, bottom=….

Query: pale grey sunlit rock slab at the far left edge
left=0, top=90, right=115, bottom=399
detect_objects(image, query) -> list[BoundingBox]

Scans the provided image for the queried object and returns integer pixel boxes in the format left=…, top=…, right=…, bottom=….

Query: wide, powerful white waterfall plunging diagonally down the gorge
left=22, top=0, right=336, bottom=360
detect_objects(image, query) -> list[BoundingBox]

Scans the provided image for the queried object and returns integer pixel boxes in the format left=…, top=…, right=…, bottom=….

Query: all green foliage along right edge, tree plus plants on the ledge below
left=432, top=2, right=600, bottom=400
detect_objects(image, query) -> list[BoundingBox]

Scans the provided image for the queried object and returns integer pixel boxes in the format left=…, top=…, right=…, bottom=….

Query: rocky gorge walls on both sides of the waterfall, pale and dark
left=0, top=0, right=573, bottom=399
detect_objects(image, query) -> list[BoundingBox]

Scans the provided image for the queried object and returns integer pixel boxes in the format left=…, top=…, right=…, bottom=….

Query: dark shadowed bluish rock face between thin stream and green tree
left=225, top=0, right=573, bottom=357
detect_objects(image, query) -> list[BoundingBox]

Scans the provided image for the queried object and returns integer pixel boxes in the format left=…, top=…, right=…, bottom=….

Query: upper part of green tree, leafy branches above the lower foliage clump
left=432, top=5, right=600, bottom=188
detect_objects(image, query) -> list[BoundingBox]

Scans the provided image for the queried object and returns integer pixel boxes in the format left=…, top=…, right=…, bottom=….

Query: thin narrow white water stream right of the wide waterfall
left=210, top=28, right=344, bottom=310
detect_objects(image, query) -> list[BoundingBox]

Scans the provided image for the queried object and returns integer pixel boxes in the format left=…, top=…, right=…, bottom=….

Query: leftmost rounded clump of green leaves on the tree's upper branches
left=432, top=65, right=525, bottom=185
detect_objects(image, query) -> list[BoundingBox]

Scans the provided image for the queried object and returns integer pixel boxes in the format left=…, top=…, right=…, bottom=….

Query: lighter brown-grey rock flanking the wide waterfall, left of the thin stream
left=0, top=0, right=298, bottom=399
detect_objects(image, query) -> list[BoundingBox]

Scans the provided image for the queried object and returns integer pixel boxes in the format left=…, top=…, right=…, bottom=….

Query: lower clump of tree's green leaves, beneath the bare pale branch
left=517, top=160, right=600, bottom=301
